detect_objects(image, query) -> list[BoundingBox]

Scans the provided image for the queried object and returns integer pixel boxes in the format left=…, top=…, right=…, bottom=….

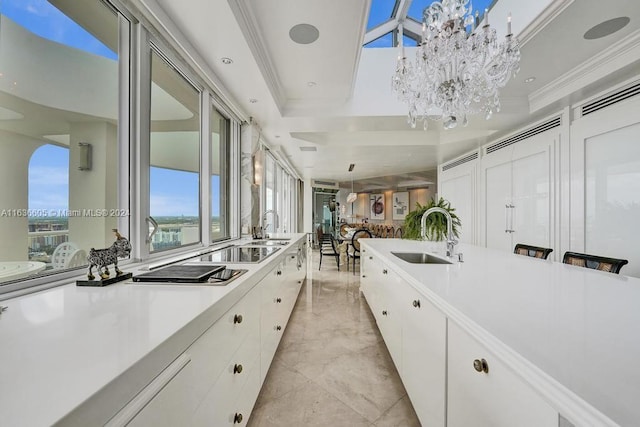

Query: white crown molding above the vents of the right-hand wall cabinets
left=529, top=30, right=640, bottom=113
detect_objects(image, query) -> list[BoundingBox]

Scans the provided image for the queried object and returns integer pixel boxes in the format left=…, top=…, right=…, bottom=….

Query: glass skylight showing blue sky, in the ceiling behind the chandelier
left=364, top=0, right=497, bottom=48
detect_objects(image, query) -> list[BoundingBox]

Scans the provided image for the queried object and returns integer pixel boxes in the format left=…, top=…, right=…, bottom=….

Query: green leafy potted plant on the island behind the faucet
left=402, top=197, right=461, bottom=241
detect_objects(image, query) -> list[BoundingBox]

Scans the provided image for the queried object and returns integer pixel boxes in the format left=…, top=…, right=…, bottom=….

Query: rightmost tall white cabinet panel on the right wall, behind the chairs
left=566, top=96, right=640, bottom=277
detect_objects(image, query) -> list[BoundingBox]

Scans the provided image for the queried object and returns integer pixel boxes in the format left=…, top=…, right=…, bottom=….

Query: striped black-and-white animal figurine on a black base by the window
left=76, top=228, right=132, bottom=286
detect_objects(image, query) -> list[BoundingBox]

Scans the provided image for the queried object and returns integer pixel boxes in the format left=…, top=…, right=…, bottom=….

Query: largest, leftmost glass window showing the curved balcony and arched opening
left=0, top=0, right=129, bottom=283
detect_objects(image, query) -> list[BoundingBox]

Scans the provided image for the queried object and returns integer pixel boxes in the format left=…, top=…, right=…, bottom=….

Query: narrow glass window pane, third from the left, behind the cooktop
left=209, top=108, right=230, bottom=241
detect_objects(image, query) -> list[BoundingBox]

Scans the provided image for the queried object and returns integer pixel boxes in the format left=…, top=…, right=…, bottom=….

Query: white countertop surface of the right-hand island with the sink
left=361, top=239, right=640, bottom=426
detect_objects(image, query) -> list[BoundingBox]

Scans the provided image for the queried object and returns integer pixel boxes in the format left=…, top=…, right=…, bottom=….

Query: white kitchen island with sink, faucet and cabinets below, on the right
left=361, top=239, right=640, bottom=426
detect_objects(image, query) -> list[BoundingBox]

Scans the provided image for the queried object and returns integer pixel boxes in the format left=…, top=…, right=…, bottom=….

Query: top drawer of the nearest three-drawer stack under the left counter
left=188, top=288, right=260, bottom=402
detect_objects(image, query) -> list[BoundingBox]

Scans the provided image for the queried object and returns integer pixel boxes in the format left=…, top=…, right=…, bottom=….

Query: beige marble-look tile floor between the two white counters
left=248, top=251, right=420, bottom=427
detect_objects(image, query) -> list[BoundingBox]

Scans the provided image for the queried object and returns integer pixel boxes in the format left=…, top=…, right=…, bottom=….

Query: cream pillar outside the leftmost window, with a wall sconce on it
left=69, top=122, right=120, bottom=253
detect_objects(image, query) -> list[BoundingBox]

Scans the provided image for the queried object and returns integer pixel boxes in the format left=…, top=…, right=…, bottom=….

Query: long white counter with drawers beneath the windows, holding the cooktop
left=0, top=234, right=306, bottom=426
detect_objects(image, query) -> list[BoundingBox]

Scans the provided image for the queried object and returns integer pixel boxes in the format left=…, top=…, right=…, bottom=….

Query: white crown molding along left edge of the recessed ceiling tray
left=228, top=0, right=287, bottom=114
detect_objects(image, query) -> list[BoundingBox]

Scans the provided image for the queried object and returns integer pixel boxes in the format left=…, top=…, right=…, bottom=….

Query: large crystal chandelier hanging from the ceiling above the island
left=392, top=0, right=520, bottom=130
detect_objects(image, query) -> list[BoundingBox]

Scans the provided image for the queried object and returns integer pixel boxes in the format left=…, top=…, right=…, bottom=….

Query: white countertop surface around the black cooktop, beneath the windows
left=0, top=234, right=305, bottom=426
